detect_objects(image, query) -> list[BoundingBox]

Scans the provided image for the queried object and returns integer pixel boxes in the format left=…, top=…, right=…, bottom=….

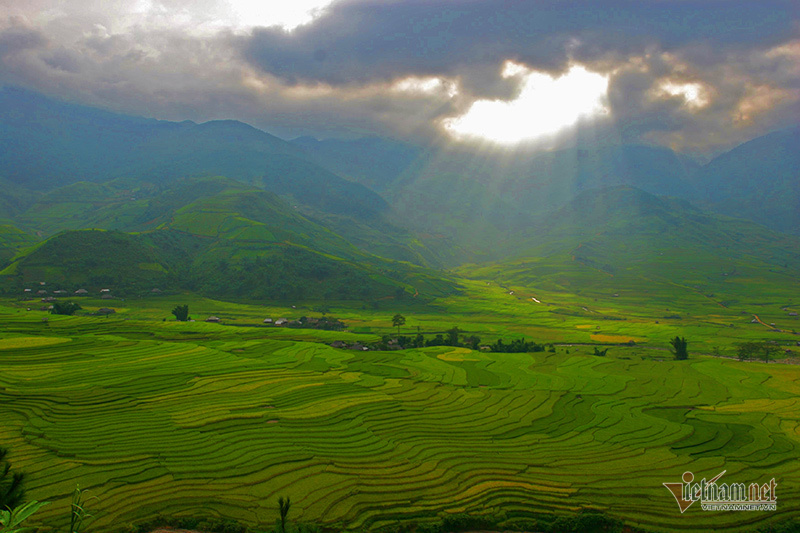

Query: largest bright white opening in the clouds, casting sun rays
left=443, top=62, right=608, bottom=144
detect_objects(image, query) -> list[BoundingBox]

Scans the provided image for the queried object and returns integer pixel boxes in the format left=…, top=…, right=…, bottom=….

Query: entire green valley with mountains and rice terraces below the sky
left=0, top=89, right=800, bottom=533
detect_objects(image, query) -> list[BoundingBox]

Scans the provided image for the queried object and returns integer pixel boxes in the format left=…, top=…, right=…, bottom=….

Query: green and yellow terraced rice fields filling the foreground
left=0, top=314, right=800, bottom=532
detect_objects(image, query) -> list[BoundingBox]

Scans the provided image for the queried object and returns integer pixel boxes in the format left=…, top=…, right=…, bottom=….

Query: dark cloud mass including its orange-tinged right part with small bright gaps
left=237, top=0, right=800, bottom=151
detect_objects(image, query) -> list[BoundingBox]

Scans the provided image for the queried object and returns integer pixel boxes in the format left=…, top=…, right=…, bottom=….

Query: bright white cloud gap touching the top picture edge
left=228, top=0, right=333, bottom=30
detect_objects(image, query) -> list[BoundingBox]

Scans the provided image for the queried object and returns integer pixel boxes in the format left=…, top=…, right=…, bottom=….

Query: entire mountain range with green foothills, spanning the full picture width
left=0, top=88, right=800, bottom=300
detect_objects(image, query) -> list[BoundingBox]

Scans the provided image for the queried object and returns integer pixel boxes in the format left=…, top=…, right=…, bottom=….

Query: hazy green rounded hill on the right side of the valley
left=461, top=186, right=800, bottom=308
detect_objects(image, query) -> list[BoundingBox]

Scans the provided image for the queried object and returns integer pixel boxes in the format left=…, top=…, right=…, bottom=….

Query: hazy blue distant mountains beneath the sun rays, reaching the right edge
left=292, top=123, right=800, bottom=244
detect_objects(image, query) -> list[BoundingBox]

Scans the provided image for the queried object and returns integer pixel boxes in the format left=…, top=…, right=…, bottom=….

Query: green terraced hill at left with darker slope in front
left=0, top=178, right=456, bottom=300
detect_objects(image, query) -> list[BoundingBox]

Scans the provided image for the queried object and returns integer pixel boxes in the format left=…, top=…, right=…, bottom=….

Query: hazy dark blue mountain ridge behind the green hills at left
left=0, top=88, right=387, bottom=220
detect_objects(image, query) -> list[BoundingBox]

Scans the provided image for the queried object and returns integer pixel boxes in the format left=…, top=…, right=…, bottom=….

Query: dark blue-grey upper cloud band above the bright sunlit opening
left=240, top=0, right=798, bottom=85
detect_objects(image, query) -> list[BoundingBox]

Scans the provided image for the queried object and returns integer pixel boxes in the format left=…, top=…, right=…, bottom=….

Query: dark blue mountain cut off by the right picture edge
left=693, top=126, right=800, bottom=234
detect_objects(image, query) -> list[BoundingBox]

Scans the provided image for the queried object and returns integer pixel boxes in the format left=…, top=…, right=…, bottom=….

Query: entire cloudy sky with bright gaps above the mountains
left=0, top=0, right=800, bottom=157
